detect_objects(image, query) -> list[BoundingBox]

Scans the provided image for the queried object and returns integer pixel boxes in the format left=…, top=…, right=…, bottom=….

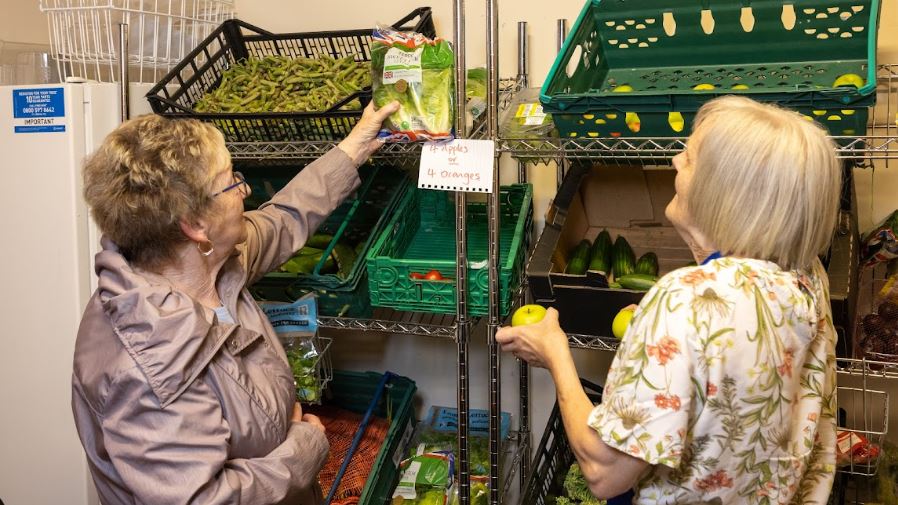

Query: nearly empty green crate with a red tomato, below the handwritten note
left=367, top=184, right=533, bottom=316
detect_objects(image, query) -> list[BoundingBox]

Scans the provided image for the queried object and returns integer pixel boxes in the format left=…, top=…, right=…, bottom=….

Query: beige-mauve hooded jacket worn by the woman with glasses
left=72, top=149, right=359, bottom=505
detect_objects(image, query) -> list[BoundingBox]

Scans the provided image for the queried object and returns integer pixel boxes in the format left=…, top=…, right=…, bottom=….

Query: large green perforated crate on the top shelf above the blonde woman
left=540, top=0, right=880, bottom=138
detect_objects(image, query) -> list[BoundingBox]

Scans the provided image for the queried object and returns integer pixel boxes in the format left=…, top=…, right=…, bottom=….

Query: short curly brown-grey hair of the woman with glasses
left=84, top=115, right=228, bottom=269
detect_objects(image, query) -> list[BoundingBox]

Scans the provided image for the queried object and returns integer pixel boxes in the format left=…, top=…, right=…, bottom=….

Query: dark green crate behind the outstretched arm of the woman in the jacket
left=244, top=165, right=409, bottom=317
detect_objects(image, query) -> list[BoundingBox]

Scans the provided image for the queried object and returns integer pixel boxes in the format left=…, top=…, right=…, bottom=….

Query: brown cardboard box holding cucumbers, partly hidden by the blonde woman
left=527, top=164, right=857, bottom=350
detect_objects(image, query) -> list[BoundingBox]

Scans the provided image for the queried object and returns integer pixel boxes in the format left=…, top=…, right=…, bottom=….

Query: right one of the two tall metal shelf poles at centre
left=486, top=0, right=502, bottom=505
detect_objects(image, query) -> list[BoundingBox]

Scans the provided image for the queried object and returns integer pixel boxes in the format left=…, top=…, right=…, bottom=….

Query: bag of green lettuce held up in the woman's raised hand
left=371, top=26, right=455, bottom=142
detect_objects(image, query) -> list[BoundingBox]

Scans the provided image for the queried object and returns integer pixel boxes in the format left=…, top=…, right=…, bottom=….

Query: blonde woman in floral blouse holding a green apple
left=496, top=97, right=841, bottom=504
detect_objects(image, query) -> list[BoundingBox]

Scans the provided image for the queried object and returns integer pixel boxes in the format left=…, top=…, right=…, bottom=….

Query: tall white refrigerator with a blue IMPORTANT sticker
left=0, top=83, right=120, bottom=505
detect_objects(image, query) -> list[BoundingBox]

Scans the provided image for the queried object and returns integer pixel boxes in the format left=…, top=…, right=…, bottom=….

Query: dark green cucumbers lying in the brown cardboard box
left=564, top=230, right=659, bottom=291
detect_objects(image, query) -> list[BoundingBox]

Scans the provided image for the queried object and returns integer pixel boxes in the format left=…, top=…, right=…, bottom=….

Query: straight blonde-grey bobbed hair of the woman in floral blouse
left=686, top=96, right=842, bottom=269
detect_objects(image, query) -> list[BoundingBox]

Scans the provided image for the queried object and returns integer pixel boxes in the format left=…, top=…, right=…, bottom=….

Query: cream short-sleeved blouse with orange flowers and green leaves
left=589, top=258, right=836, bottom=504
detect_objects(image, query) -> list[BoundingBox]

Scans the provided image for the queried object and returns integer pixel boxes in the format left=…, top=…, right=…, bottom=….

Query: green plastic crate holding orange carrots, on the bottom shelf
left=325, top=370, right=417, bottom=505
